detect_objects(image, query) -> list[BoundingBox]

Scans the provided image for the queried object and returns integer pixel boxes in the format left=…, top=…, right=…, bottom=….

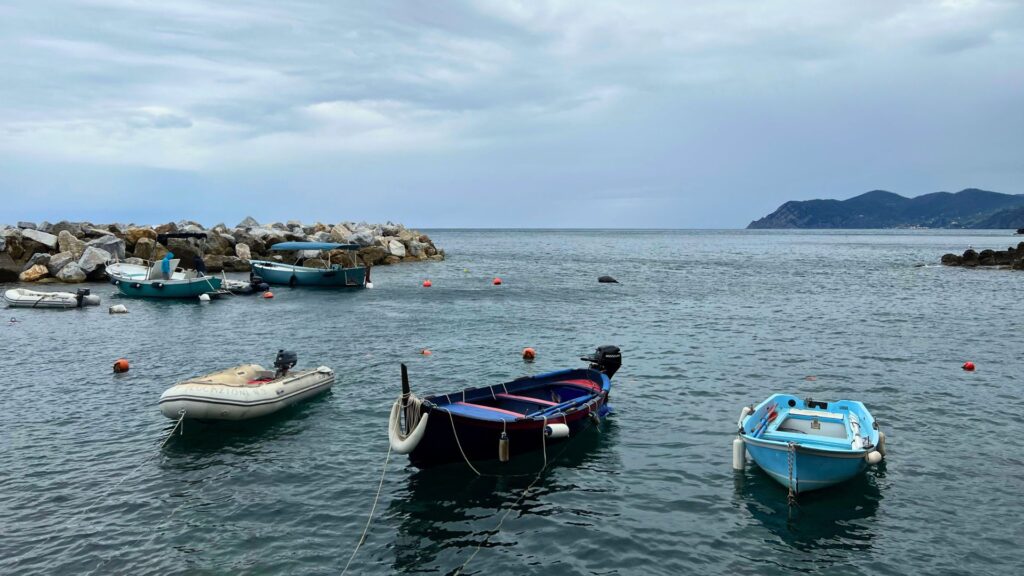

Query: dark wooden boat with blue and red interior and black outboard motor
left=388, top=346, right=622, bottom=468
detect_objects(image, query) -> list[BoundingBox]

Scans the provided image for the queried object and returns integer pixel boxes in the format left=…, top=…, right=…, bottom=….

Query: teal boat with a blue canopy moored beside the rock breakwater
left=250, top=242, right=373, bottom=288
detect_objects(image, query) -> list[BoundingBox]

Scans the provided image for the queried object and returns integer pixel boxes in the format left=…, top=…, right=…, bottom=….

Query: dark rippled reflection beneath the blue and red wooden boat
left=385, top=419, right=617, bottom=573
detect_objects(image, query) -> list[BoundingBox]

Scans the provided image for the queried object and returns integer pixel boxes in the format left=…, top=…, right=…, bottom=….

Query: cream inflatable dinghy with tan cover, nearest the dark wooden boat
left=160, top=364, right=334, bottom=420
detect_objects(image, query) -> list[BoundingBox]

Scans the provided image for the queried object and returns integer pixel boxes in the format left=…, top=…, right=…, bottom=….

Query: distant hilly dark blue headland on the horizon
left=746, top=188, right=1024, bottom=229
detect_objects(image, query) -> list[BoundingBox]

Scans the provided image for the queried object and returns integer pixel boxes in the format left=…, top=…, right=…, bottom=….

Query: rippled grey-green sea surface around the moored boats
left=0, top=231, right=1024, bottom=575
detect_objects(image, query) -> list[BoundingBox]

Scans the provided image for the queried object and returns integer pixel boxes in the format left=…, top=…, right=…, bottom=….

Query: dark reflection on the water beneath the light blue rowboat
left=735, top=461, right=886, bottom=552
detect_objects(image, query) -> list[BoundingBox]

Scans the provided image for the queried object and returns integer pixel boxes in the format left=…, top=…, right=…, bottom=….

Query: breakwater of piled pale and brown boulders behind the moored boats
left=0, top=217, right=444, bottom=283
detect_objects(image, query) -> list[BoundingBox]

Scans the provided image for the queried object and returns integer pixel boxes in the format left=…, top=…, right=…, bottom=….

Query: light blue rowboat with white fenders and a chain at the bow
left=733, top=394, right=885, bottom=494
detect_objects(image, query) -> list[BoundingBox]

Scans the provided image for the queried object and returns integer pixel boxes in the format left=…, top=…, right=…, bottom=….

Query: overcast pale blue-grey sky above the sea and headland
left=0, top=0, right=1024, bottom=229
